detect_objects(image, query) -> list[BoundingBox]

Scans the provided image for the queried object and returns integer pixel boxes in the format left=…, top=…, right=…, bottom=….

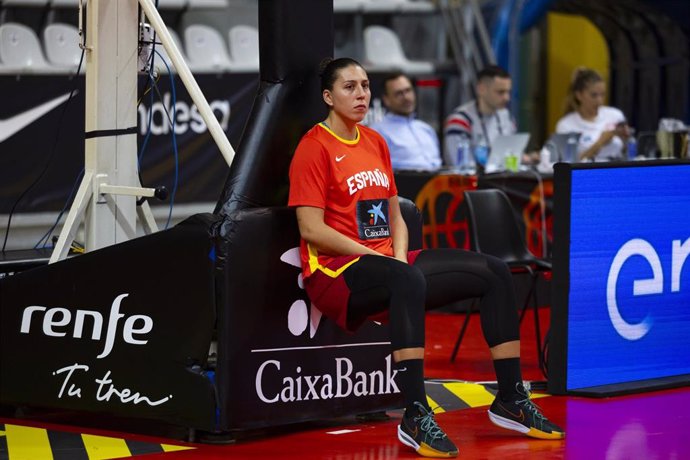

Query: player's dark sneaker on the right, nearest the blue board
left=489, top=383, right=565, bottom=439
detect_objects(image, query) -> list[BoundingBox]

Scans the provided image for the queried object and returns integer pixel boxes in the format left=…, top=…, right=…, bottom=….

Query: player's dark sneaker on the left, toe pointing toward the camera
left=398, top=402, right=458, bottom=458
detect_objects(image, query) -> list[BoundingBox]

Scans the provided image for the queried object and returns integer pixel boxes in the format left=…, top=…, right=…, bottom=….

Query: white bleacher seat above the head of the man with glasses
left=364, top=26, right=434, bottom=74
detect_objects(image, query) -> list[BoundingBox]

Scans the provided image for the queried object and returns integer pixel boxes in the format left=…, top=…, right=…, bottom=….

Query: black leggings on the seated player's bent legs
left=343, top=249, right=520, bottom=350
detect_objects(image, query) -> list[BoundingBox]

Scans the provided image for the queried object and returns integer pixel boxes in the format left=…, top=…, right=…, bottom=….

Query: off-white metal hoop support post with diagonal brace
left=50, top=0, right=235, bottom=263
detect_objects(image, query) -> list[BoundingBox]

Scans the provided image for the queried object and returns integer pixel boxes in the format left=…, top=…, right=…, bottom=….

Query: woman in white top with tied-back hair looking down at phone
left=556, top=67, right=630, bottom=162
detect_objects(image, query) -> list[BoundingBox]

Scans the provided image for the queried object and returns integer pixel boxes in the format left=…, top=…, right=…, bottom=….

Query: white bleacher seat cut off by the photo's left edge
left=0, top=22, right=52, bottom=73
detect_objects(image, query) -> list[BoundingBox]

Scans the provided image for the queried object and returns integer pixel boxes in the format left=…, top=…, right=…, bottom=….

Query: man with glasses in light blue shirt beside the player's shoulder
left=372, top=73, right=441, bottom=170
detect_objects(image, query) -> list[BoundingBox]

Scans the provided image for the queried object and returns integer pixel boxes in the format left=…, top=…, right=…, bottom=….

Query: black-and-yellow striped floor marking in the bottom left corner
left=0, top=424, right=193, bottom=460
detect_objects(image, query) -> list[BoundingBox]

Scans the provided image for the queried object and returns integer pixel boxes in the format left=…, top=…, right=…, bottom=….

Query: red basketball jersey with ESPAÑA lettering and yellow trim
left=288, top=123, right=398, bottom=278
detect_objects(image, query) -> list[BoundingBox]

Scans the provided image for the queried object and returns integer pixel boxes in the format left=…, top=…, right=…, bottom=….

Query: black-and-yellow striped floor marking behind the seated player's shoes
left=424, top=380, right=548, bottom=414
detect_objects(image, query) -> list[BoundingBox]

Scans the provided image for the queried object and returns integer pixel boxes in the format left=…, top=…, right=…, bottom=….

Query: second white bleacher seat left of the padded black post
left=184, top=24, right=232, bottom=72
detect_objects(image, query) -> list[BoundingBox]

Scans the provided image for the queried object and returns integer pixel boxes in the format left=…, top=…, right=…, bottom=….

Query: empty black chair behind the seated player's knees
left=451, top=189, right=551, bottom=371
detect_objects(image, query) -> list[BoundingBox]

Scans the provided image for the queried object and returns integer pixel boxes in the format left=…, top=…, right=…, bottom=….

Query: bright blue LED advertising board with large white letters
left=566, top=165, right=690, bottom=390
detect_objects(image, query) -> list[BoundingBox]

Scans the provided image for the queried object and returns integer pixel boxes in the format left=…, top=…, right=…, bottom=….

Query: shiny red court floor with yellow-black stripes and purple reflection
left=0, top=310, right=690, bottom=460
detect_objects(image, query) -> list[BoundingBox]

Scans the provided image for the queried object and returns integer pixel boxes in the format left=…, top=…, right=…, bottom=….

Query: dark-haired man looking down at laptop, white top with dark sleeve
left=443, top=65, right=516, bottom=165
